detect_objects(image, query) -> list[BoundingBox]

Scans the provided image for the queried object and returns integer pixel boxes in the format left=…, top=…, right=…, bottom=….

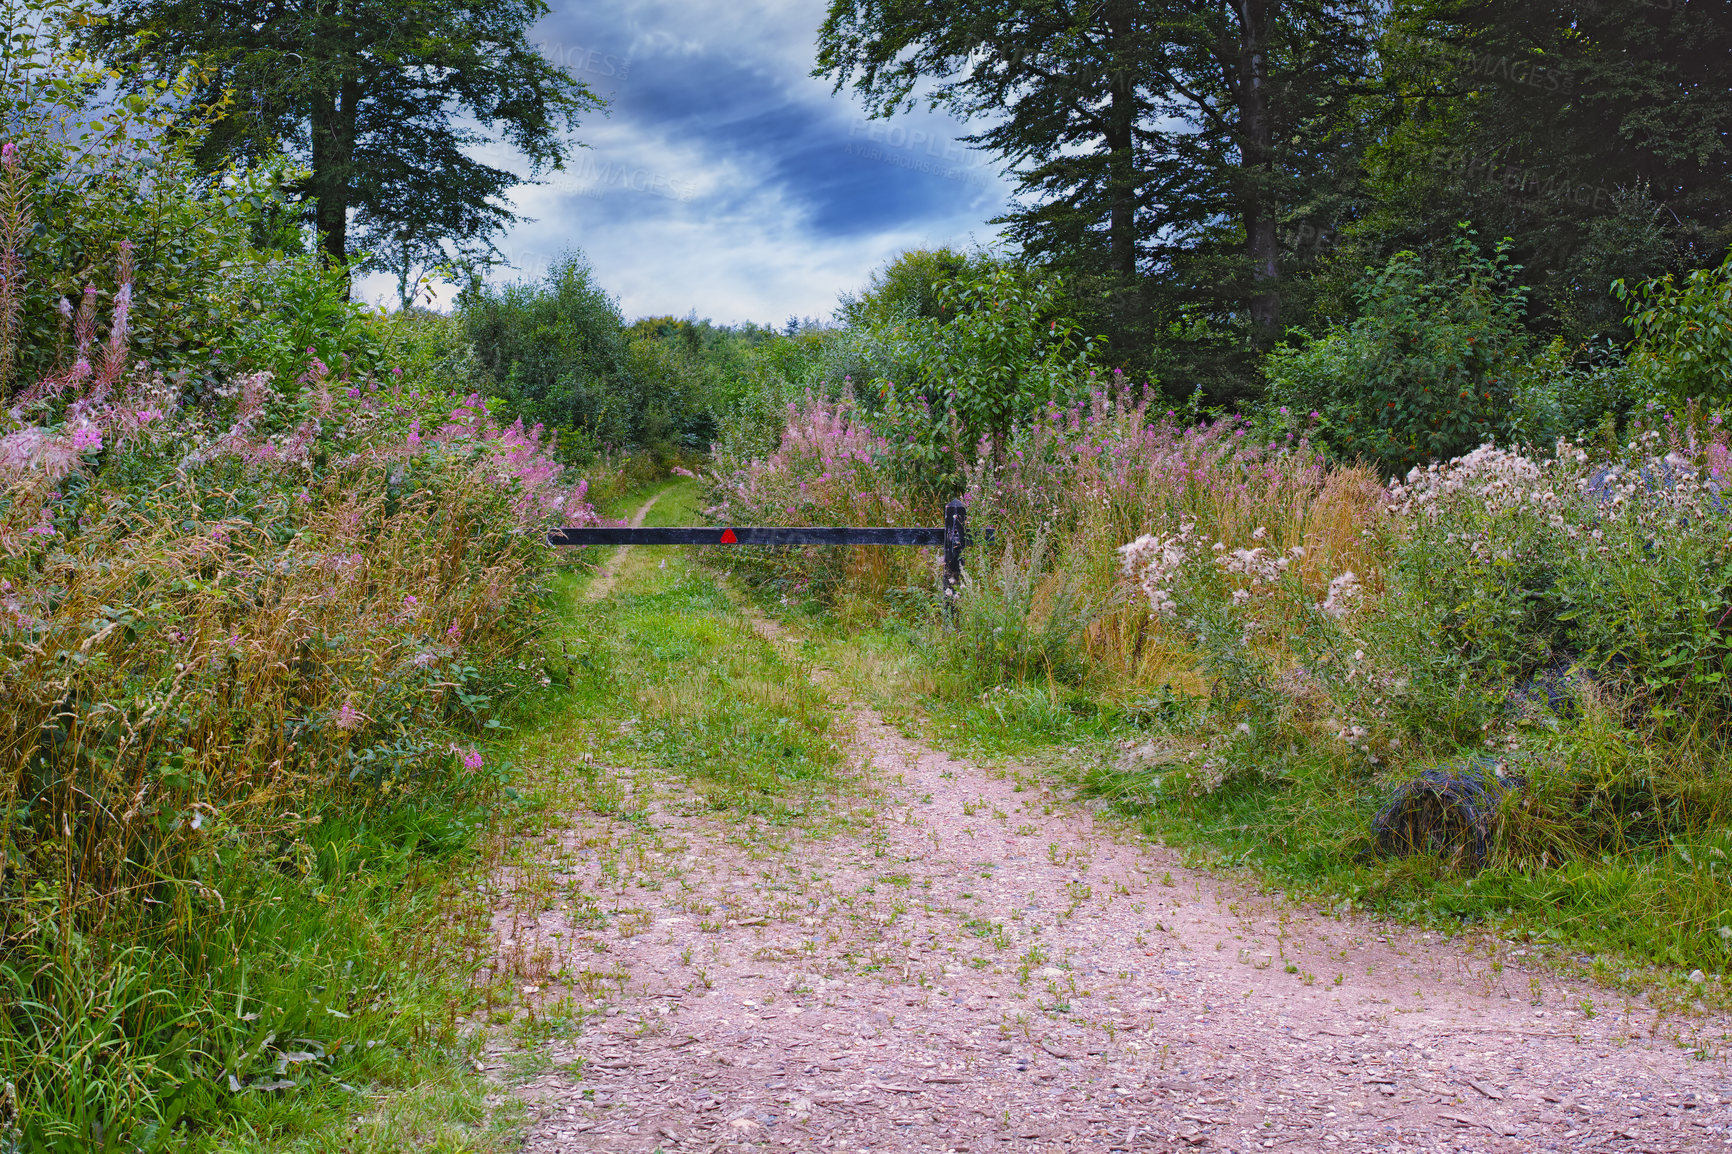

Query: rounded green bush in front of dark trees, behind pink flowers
left=1264, top=230, right=1526, bottom=475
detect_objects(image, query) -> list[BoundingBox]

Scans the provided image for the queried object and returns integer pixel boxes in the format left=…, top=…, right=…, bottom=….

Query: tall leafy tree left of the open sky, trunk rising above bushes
left=88, top=0, right=601, bottom=282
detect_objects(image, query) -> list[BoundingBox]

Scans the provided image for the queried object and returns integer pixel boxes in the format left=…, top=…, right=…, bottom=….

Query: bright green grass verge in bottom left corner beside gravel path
left=0, top=758, right=504, bottom=1154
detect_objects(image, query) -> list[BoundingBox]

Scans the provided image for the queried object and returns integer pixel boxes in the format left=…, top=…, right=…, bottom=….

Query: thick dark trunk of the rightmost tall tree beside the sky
left=1235, top=0, right=1282, bottom=348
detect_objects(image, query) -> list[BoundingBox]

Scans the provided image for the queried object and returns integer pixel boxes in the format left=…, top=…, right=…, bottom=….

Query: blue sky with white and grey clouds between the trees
left=360, top=0, right=1008, bottom=324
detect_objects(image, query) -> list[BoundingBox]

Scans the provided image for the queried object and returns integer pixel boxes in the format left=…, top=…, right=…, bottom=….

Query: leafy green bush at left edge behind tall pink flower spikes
left=0, top=0, right=378, bottom=400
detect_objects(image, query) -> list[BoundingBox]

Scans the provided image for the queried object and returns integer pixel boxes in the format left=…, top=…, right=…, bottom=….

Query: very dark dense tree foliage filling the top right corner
left=1337, top=0, right=1732, bottom=341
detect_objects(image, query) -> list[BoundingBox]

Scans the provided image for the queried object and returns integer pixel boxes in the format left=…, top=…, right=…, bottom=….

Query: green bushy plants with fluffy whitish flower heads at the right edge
left=1391, top=428, right=1732, bottom=714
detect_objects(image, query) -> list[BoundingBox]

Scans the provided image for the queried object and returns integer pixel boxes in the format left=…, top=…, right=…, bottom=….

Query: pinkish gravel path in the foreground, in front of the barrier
left=499, top=512, right=1732, bottom=1154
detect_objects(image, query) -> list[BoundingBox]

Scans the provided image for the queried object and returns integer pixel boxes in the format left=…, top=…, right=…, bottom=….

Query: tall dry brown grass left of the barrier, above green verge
left=0, top=450, right=544, bottom=941
